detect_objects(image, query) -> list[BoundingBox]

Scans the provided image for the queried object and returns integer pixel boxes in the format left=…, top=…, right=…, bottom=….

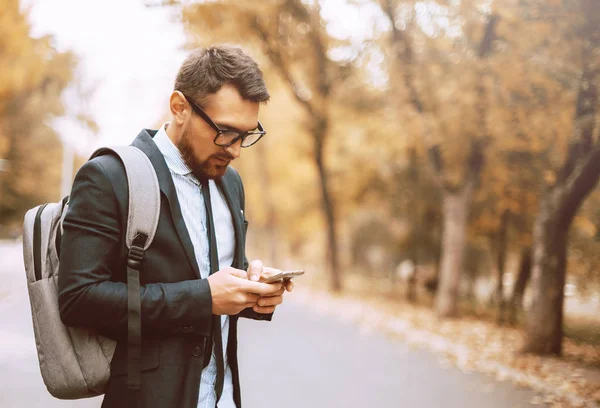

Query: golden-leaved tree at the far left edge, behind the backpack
left=0, top=0, right=75, bottom=223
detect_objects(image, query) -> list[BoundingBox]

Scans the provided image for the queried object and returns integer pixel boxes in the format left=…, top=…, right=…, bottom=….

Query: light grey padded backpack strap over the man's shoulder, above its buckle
left=90, top=146, right=160, bottom=251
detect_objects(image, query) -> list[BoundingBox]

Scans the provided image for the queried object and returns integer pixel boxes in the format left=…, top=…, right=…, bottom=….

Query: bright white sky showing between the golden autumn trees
left=21, top=0, right=384, bottom=155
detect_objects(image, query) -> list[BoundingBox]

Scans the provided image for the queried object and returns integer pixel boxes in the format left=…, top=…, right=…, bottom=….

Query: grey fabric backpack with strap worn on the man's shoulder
left=23, top=146, right=160, bottom=399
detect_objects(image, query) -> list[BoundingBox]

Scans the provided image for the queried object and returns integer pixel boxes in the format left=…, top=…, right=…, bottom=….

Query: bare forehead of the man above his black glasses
left=204, top=85, right=260, bottom=130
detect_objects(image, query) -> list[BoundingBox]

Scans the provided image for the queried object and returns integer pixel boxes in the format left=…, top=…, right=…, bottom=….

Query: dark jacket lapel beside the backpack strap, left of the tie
left=132, top=129, right=202, bottom=278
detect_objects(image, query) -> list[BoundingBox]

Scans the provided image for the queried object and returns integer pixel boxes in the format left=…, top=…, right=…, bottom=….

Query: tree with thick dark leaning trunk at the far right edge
left=523, top=0, right=600, bottom=354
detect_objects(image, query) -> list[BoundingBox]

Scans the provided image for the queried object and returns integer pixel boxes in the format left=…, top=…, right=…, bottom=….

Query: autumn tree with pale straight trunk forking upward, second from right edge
left=381, top=0, right=498, bottom=316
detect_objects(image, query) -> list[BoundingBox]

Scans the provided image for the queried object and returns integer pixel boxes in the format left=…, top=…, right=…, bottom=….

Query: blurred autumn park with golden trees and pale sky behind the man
left=0, top=0, right=600, bottom=401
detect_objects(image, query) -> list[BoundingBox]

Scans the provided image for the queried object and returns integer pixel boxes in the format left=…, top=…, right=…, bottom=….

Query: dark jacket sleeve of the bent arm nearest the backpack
left=58, top=160, right=212, bottom=338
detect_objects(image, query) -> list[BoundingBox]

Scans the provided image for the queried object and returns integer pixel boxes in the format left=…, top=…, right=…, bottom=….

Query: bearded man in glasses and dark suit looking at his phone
left=58, top=46, right=293, bottom=408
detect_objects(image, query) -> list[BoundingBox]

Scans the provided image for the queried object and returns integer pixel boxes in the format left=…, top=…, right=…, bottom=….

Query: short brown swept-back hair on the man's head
left=175, top=45, right=270, bottom=107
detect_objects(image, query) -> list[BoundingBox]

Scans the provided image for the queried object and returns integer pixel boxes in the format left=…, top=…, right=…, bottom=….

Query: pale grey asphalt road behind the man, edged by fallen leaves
left=0, top=242, right=535, bottom=408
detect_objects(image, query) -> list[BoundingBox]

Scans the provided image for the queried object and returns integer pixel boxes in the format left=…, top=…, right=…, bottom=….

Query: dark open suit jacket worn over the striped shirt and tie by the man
left=58, top=130, right=271, bottom=408
